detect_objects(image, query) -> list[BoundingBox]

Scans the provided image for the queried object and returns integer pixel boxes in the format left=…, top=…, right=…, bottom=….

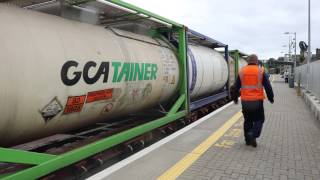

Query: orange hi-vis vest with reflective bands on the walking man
left=239, top=65, right=265, bottom=101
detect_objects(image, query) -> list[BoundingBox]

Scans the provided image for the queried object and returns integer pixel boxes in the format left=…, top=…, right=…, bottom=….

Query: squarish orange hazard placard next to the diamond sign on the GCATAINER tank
left=63, top=95, right=86, bottom=114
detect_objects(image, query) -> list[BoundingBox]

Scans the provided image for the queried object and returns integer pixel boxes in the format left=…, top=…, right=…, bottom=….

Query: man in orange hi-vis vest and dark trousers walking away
left=233, top=54, right=274, bottom=147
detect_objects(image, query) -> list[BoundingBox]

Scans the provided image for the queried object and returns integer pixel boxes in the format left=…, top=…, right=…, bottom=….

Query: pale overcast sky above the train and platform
left=125, top=0, right=320, bottom=59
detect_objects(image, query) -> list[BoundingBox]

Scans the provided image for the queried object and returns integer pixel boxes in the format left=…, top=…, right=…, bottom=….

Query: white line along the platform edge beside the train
left=87, top=101, right=233, bottom=180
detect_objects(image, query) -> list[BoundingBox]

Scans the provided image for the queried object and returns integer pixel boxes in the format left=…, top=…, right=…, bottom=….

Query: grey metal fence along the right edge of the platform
left=295, top=61, right=320, bottom=97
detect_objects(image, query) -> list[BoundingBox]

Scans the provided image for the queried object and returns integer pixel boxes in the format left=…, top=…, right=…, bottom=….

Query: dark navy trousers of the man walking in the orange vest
left=241, top=100, right=264, bottom=141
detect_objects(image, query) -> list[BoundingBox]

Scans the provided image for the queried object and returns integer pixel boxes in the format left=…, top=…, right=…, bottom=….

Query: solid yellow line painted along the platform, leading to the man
left=157, top=111, right=242, bottom=180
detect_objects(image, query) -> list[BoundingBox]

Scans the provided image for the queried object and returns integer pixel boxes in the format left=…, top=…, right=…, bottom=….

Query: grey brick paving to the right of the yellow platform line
left=178, top=78, right=320, bottom=180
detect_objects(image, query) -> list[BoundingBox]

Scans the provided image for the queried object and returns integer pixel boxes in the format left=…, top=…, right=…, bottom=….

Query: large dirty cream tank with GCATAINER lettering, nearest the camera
left=0, top=5, right=180, bottom=146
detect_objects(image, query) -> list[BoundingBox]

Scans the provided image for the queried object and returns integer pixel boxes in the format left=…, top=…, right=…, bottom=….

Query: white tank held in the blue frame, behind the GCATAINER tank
left=188, top=45, right=228, bottom=100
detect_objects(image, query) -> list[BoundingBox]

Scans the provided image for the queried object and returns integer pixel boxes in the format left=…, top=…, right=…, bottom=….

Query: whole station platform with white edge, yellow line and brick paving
left=89, top=76, right=320, bottom=180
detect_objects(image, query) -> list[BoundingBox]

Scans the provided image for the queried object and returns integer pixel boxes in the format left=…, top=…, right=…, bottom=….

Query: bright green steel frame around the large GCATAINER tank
left=0, top=0, right=189, bottom=179
